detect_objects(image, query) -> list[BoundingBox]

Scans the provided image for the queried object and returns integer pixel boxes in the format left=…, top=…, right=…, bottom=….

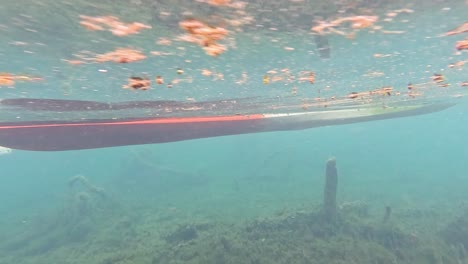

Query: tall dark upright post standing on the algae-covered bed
left=323, top=158, right=338, bottom=221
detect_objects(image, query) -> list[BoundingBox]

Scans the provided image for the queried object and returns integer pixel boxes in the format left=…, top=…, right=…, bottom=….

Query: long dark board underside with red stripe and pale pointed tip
left=0, top=101, right=451, bottom=151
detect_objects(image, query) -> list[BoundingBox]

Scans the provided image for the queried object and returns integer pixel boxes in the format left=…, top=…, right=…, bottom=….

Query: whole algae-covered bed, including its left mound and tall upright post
left=0, top=159, right=468, bottom=264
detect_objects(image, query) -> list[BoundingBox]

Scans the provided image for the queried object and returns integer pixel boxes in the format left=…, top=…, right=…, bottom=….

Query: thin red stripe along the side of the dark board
left=0, top=114, right=265, bottom=129
